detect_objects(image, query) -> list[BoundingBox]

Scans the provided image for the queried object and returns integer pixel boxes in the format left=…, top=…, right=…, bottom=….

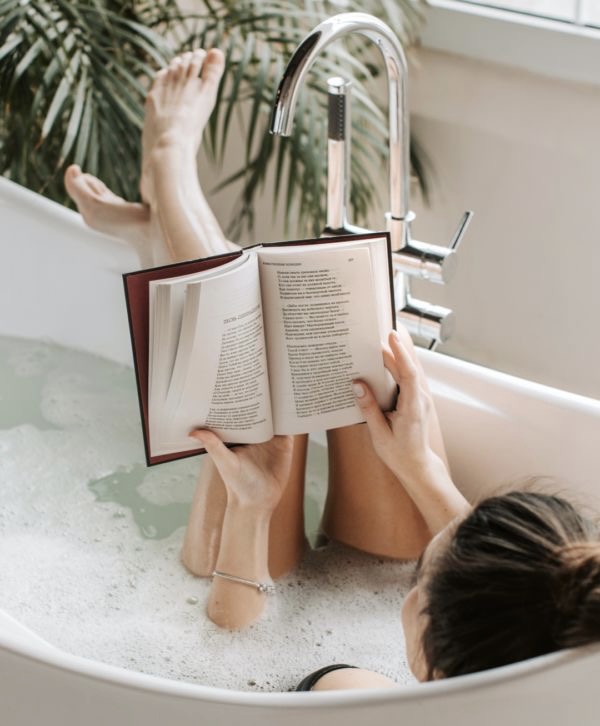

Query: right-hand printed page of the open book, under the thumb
left=258, top=243, right=395, bottom=434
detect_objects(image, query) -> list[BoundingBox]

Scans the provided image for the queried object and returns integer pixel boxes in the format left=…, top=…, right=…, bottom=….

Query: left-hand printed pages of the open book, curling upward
left=153, top=253, right=273, bottom=454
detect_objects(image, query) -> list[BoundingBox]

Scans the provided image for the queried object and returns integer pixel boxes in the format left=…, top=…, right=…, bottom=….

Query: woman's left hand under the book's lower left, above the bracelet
left=190, top=429, right=293, bottom=511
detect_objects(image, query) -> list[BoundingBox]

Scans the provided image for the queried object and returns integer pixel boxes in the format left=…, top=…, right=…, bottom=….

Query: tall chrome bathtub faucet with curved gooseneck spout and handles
left=271, top=13, right=472, bottom=348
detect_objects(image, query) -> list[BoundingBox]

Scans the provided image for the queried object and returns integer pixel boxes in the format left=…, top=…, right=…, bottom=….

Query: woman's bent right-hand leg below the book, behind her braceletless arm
left=322, top=328, right=448, bottom=559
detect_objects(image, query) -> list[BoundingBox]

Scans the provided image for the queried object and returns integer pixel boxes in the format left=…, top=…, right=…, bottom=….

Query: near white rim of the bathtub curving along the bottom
left=0, top=610, right=600, bottom=709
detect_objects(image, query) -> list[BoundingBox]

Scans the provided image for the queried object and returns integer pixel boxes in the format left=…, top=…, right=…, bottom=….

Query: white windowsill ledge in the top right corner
left=421, top=0, right=600, bottom=86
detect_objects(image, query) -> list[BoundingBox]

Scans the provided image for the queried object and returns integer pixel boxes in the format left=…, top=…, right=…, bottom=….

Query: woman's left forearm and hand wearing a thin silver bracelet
left=186, top=430, right=293, bottom=630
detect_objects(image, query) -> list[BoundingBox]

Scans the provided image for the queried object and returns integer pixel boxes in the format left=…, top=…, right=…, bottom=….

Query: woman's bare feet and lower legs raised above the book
left=65, top=51, right=239, bottom=265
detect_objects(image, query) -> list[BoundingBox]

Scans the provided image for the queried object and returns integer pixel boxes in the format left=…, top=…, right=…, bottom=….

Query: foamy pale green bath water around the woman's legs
left=0, top=338, right=413, bottom=691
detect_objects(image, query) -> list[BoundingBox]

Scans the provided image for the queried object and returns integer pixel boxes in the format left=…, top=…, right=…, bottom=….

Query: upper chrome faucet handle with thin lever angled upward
left=394, top=211, right=473, bottom=284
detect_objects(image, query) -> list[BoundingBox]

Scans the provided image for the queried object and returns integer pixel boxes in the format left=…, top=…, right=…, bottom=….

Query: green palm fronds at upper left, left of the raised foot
left=0, top=0, right=172, bottom=201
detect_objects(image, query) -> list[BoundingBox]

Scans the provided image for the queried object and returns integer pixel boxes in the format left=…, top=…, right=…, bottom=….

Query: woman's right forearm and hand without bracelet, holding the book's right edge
left=354, top=331, right=471, bottom=534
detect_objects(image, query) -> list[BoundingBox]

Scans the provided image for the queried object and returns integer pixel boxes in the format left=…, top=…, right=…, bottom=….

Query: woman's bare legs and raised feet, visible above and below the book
left=65, top=49, right=445, bottom=592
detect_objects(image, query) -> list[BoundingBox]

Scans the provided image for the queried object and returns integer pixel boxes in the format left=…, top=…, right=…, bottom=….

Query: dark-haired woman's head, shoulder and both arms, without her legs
left=193, top=332, right=600, bottom=690
